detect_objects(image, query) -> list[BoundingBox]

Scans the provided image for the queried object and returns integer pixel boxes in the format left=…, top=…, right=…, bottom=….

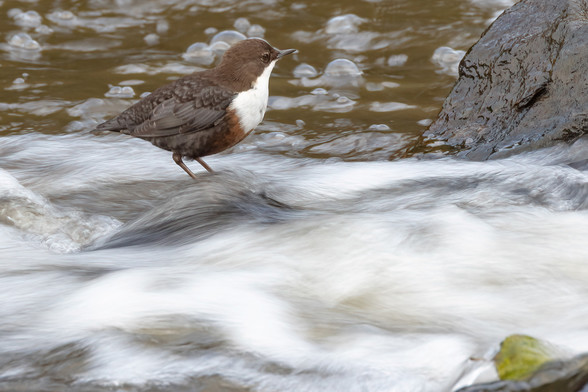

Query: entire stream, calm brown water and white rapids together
left=0, top=0, right=588, bottom=392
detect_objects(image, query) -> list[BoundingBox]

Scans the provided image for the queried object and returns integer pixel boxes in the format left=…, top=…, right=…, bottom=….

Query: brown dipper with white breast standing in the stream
left=95, top=38, right=296, bottom=178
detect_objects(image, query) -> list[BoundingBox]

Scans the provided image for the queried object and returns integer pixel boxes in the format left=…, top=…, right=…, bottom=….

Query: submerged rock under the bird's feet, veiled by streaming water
left=86, top=172, right=299, bottom=250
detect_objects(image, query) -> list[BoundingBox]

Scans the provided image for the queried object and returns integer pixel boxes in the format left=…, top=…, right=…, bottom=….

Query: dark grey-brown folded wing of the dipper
left=128, top=86, right=234, bottom=138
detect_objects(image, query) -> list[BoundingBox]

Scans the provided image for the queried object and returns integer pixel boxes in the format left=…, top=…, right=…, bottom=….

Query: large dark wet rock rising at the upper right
left=424, top=0, right=588, bottom=160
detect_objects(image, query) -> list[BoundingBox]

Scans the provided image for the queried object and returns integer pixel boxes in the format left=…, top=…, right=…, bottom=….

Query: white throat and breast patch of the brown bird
left=229, top=60, right=277, bottom=133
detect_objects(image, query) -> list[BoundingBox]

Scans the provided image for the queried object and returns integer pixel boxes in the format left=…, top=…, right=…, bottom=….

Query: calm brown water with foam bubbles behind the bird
left=0, top=0, right=500, bottom=159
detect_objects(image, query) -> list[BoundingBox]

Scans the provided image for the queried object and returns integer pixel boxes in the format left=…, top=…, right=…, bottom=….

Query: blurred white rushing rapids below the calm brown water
left=0, top=134, right=588, bottom=392
